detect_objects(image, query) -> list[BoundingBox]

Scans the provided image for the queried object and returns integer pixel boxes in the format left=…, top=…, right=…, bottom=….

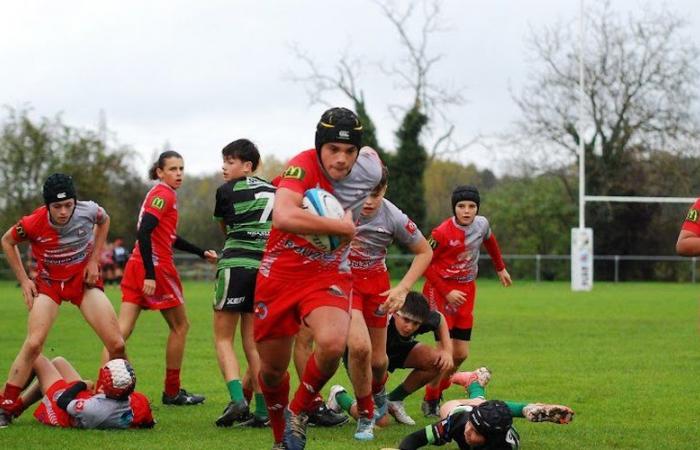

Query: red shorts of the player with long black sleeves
left=121, top=258, right=185, bottom=310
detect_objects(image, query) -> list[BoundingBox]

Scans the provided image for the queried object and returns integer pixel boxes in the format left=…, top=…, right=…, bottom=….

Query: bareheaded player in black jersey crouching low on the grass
left=327, top=291, right=452, bottom=425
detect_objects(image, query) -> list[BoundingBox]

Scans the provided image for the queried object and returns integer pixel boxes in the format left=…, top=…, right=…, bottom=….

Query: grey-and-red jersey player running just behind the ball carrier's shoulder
left=348, top=168, right=433, bottom=440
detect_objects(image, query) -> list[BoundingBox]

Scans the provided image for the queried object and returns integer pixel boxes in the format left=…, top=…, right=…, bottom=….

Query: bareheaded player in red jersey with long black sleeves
left=113, top=150, right=217, bottom=405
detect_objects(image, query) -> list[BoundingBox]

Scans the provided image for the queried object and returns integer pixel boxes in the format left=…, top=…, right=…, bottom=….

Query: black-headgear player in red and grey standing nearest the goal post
left=422, top=186, right=512, bottom=416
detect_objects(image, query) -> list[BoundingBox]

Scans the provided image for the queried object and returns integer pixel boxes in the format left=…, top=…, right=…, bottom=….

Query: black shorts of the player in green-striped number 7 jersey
left=214, top=267, right=258, bottom=313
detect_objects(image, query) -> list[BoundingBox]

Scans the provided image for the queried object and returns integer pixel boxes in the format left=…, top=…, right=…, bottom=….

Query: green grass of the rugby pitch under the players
left=0, top=280, right=700, bottom=450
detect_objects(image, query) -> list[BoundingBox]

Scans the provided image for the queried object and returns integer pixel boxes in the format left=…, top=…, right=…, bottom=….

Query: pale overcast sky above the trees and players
left=0, top=0, right=700, bottom=177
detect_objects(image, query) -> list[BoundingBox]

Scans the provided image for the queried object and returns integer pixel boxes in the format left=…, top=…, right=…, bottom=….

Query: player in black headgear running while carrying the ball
left=255, top=108, right=382, bottom=450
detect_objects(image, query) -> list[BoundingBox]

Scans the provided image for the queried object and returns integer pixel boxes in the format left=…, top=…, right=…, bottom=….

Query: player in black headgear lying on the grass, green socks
left=392, top=372, right=574, bottom=450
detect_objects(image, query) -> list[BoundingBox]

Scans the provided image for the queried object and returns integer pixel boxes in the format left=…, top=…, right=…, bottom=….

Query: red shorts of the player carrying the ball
left=253, top=272, right=352, bottom=342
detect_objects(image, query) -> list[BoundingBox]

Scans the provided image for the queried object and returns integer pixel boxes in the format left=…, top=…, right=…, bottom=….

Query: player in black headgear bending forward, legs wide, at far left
left=0, top=173, right=125, bottom=426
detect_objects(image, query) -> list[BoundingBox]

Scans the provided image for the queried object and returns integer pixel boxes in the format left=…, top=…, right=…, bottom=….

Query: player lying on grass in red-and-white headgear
left=8, top=355, right=155, bottom=429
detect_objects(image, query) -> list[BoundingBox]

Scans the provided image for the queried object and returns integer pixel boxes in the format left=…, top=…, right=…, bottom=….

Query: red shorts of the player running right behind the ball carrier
left=352, top=271, right=391, bottom=328
